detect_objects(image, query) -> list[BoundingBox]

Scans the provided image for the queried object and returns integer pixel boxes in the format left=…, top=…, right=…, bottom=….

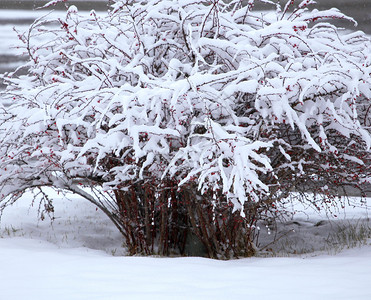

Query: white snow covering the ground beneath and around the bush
left=0, top=194, right=371, bottom=300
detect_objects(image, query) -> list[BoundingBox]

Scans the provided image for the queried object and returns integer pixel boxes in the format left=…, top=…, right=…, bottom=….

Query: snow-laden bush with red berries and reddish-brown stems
left=0, top=0, right=371, bottom=257
